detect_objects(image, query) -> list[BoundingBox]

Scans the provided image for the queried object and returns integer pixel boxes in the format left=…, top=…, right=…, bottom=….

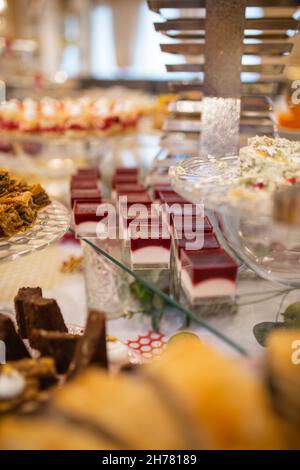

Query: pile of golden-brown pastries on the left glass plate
left=0, top=168, right=50, bottom=238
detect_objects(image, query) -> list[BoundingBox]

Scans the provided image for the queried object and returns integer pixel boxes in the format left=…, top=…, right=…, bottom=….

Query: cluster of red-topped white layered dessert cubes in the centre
left=71, top=167, right=238, bottom=308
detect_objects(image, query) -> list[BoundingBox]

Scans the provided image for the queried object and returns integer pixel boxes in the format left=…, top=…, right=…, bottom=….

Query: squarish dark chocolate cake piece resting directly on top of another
left=24, top=296, right=68, bottom=338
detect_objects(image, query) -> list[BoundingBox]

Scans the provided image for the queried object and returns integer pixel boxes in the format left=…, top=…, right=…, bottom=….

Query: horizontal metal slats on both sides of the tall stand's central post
left=148, top=0, right=299, bottom=155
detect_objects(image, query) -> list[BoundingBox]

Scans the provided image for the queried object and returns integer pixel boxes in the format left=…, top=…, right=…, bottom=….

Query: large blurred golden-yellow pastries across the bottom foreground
left=0, top=332, right=299, bottom=450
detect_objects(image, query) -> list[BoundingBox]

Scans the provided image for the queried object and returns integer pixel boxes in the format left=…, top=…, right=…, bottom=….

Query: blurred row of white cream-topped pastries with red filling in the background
left=0, top=97, right=155, bottom=137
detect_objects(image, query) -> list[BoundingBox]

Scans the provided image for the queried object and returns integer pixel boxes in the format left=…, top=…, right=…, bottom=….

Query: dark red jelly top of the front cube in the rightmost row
left=181, top=249, right=238, bottom=285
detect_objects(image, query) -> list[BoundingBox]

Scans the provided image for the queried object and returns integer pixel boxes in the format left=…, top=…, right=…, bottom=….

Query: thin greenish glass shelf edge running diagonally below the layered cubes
left=79, top=235, right=248, bottom=356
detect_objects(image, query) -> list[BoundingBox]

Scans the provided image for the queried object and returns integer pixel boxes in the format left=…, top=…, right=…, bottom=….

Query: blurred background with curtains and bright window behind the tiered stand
left=0, top=0, right=300, bottom=98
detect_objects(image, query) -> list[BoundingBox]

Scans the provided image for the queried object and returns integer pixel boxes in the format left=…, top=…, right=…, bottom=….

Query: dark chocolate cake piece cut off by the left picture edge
left=0, top=313, right=30, bottom=361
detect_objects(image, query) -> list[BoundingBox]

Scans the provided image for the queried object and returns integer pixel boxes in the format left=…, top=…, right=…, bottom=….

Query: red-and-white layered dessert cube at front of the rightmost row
left=181, top=249, right=238, bottom=303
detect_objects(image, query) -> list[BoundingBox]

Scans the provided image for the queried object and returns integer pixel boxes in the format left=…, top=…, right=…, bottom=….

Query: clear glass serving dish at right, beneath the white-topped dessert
left=170, top=156, right=300, bottom=288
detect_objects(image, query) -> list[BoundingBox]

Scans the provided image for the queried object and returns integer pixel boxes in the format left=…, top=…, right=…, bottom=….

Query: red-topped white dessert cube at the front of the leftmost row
left=73, top=201, right=107, bottom=237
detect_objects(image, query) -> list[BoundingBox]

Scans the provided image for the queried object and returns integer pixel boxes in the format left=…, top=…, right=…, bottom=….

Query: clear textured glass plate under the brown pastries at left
left=0, top=201, right=70, bottom=263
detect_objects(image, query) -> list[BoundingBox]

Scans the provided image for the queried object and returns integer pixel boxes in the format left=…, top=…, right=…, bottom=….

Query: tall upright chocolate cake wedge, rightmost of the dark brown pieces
left=69, top=310, right=107, bottom=376
